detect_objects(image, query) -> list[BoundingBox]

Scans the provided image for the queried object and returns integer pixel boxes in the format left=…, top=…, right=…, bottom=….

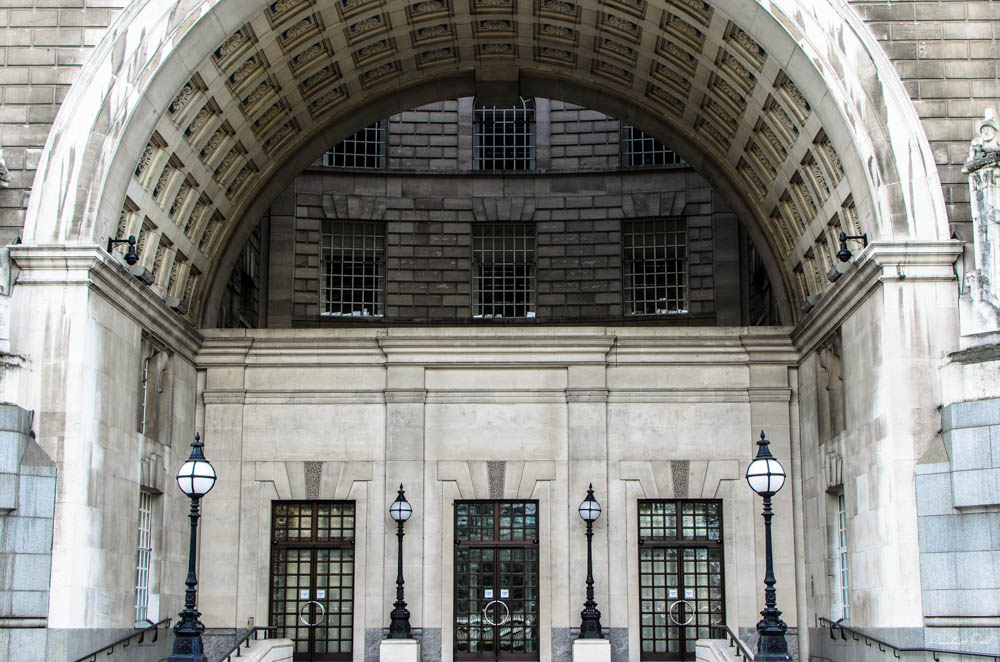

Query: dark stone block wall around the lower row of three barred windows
left=282, top=169, right=739, bottom=326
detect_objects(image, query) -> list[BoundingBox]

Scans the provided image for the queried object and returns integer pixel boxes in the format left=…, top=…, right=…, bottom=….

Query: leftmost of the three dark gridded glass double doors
left=270, top=501, right=354, bottom=662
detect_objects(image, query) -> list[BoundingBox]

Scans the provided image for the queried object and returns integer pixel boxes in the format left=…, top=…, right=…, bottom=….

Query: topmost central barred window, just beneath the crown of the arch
left=474, top=97, right=535, bottom=170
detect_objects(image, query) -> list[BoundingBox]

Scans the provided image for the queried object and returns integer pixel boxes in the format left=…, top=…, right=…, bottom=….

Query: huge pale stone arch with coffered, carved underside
left=25, top=0, right=948, bottom=323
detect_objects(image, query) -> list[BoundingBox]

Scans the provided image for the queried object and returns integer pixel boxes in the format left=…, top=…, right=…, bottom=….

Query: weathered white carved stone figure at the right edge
left=961, top=108, right=1000, bottom=335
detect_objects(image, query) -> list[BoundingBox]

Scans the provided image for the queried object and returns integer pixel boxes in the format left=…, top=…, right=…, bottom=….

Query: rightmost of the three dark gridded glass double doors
left=639, top=501, right=725, bottom=660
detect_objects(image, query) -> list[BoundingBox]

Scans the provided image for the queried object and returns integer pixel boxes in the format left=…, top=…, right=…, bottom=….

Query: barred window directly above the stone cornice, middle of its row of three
left=472, top=223, right=535, bottom=319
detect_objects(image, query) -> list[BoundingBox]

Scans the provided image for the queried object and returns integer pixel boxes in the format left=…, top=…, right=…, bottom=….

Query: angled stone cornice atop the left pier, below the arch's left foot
left=10, top=244, right=203, bottom=362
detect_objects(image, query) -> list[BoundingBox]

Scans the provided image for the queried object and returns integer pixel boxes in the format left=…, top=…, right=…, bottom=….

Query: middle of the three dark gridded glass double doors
left=454, top=501, right=538, bottom=660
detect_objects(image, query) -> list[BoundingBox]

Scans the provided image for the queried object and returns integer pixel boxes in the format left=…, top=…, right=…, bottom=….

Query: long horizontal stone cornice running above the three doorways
left=197, top=326, right=799, bottom=368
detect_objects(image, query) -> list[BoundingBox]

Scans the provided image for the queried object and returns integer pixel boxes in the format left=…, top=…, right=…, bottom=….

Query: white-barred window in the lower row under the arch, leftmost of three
left=320, top=221, right=385, bottom=317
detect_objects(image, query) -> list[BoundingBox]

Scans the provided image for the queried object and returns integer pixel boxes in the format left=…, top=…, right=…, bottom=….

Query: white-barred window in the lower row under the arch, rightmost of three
left=622, top=218, right=687, bottom=315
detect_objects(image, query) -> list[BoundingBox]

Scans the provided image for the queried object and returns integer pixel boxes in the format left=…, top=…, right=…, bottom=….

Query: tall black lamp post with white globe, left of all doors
left=168, top=434, right=215, bottom=662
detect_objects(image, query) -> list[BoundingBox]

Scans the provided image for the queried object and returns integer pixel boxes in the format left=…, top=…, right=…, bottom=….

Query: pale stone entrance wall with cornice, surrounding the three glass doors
left=197, top=327, right=797, bottom=660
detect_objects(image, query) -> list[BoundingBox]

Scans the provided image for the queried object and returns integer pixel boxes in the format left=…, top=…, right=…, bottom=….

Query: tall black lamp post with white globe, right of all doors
left=747, top=430, right=791, bottom=662
